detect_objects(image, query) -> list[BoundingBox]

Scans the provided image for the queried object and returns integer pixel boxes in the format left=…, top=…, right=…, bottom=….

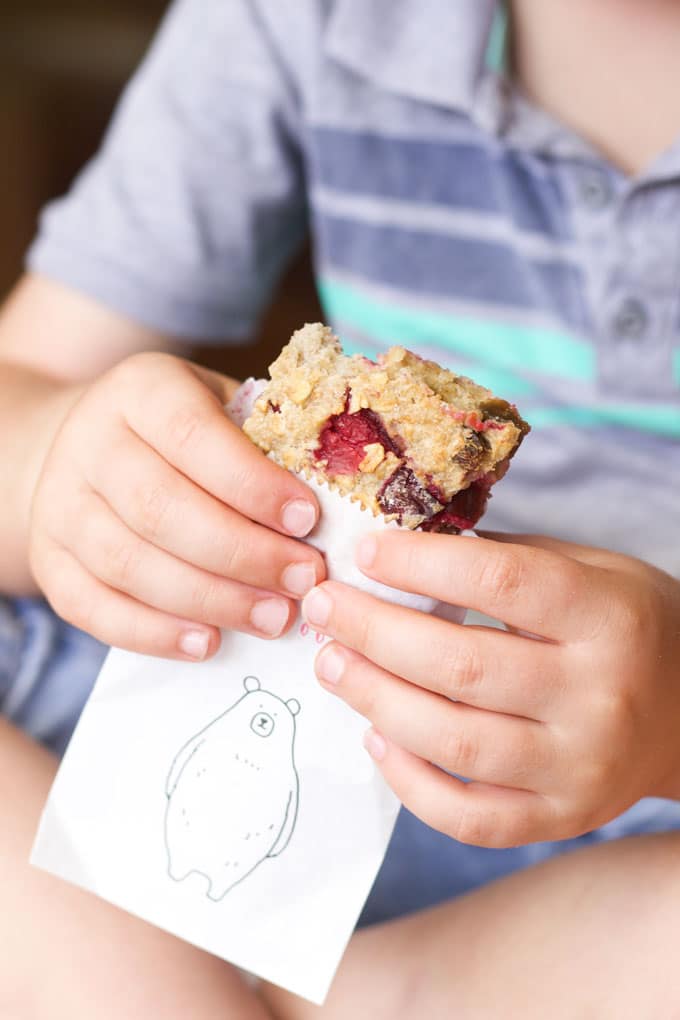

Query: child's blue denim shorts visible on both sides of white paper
left=5, top=599, right=680, bottom=924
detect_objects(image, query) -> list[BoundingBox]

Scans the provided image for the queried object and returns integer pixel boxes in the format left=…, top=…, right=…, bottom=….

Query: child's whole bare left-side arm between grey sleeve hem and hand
left=0, top=276, right=193, bottom=595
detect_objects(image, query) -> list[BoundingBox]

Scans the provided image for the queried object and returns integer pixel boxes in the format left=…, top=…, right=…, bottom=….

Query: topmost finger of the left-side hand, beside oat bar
left=116, top=355, right=318, bottom=538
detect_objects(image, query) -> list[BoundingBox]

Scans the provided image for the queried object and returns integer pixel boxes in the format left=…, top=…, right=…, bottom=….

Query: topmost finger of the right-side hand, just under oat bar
left=357, top=530, right=603, bottom=641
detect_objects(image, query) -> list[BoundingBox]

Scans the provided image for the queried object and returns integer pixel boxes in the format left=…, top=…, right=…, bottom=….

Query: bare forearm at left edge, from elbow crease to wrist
left=0, top=360, right=83, bottom=596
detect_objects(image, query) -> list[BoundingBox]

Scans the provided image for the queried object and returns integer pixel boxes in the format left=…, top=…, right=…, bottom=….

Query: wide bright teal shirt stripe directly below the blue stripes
left=319, top=278, right=595, bottom=383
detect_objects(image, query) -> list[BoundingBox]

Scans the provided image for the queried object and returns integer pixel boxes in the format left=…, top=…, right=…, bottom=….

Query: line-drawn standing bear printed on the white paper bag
left=165, top=676, right=300, bottom=901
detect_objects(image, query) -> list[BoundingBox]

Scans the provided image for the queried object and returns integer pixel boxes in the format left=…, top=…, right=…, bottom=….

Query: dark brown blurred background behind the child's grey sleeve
left=0, top=0, right=321, bottom=377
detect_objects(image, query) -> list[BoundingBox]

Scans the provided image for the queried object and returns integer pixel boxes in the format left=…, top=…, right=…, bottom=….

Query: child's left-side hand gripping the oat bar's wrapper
left=30, top=354, right=325, bottom=659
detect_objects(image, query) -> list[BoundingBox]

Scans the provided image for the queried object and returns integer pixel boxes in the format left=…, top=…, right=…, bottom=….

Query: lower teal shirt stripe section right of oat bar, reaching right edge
left=526, top=404, right=680, bottom=439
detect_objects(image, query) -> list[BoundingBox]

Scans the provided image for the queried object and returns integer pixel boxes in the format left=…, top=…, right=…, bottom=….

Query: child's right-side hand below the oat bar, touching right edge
left=304, top=532, right=680, bottom=847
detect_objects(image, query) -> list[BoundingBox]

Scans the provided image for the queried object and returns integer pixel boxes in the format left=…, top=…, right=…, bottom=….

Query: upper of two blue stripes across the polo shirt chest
left=310, top=126, right=572, bottom=240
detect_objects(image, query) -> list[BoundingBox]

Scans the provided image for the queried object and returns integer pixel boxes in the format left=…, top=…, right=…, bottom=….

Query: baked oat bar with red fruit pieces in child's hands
left=244, top=322, right=529, bottom=532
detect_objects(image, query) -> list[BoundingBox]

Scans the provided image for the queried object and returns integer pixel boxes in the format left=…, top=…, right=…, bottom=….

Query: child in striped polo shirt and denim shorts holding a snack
left=0, top=0, right=680, bottom=1020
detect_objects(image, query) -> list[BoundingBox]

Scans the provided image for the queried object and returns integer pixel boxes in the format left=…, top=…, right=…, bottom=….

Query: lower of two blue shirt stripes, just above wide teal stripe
left=315, top=212, right=589, bottom=332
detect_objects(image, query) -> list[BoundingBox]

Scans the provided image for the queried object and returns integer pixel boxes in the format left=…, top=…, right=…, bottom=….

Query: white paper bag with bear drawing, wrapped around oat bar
left=32, top=380, right=463, bottom=1004
